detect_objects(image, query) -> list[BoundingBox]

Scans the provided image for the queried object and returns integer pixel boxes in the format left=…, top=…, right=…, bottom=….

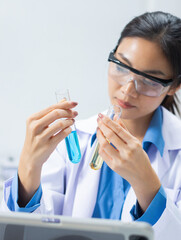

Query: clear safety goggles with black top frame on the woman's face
left=108, top=49, right=173, bottom=97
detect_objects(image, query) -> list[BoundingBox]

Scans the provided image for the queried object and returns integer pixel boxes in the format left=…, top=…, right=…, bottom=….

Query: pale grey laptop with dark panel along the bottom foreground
left=0, top=212, right=154, bottom=240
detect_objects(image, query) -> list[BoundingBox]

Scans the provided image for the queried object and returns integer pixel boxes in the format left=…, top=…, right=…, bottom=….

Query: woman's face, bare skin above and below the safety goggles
left=108, top=37, right=172, bottom=119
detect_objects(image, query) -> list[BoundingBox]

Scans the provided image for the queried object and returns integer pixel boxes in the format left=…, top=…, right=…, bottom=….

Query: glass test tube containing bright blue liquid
left=55, top=89, right=81, bottom=163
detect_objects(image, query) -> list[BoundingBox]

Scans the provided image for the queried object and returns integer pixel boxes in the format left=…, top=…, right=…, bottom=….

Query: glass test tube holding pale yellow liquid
left=90, top=105, right=121, bottom=170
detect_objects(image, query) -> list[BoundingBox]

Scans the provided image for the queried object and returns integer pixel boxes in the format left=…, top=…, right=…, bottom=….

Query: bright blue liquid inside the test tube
left=65, top=131, right=81, bottom=163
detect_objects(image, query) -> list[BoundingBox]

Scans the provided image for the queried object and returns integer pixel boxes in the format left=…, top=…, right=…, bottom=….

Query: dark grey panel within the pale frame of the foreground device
left=0, top=224, right=148, bottom=240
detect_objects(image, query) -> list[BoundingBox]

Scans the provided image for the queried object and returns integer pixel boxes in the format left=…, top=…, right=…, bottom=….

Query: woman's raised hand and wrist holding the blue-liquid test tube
left=18, top=100, right=78, bottom=206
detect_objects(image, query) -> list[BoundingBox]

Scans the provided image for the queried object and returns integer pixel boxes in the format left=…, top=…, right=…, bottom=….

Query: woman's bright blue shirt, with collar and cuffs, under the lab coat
left=7, top=107, right=166, bottom=225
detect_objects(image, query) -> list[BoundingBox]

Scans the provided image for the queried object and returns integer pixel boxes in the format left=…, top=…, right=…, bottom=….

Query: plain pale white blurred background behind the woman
left=0, top=0, right=181, bottom=198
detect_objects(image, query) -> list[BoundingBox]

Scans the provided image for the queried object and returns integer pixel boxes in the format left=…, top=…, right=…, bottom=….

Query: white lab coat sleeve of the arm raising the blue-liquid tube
left=0, top=141, right=67, bottom=215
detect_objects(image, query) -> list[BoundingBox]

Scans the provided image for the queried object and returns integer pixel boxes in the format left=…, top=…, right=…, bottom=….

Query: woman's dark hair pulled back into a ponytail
left=117, top=11, right=181, bottom=114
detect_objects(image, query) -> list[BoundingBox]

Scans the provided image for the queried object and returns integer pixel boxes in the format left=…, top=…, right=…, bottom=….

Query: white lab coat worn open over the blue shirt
left=1, top=108, right=181, bottom=240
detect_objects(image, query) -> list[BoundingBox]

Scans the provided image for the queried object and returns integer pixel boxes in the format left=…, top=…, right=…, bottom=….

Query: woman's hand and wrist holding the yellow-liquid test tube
left=97, top=114, right=161, bottom=211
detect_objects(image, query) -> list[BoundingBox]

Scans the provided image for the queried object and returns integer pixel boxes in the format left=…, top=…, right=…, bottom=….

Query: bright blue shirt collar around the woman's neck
left=91, top=107, right=165, bottom=156
